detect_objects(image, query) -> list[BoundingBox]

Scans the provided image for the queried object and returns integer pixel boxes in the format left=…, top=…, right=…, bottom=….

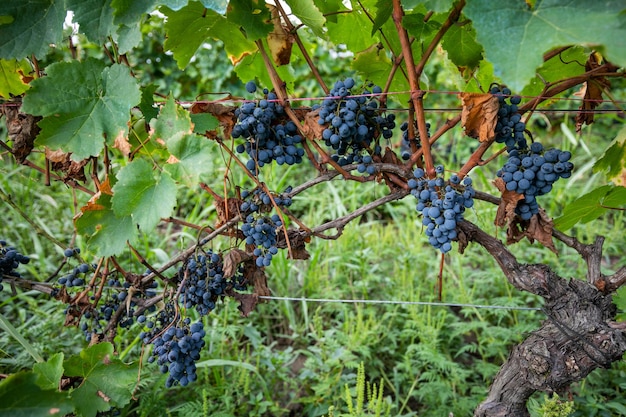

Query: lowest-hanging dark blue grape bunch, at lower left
left=148, top=318, right=206, bottom=388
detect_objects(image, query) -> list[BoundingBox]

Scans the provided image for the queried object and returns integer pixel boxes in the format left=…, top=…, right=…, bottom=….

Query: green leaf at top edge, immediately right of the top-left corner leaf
left=66, top=0, right=117, bottom=44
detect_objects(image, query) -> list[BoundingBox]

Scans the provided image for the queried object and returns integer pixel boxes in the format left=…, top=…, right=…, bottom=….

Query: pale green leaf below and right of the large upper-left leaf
left=112, top=159, right=177, bottom=231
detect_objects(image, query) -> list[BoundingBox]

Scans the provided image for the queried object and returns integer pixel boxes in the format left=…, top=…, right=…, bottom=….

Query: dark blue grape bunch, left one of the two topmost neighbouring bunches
left=231, top=81, right=304, bottom=175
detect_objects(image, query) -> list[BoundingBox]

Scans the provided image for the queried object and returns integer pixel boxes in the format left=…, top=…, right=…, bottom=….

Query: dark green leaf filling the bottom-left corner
left=0, top=372, right=74, bottom=417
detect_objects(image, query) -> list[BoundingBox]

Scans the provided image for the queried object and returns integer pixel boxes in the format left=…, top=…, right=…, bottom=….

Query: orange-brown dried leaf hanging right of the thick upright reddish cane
left=459, top=93, right=500, bottom=142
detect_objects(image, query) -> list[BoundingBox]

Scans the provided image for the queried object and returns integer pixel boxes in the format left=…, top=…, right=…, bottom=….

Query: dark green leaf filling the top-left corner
left=0, top=0, right=66, bottom=59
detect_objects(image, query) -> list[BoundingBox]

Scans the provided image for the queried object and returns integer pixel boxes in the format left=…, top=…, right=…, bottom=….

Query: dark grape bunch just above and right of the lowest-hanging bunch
left=178, top=250, right=245, bottom=316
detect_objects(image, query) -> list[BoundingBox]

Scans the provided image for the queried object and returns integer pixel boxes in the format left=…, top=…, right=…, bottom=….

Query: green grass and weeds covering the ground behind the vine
left=0, top=114, right=626, bottom=417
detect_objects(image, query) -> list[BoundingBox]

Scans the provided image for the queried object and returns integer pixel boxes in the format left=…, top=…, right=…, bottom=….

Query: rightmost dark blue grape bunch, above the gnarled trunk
left=497, top=142, right=574, bottom=220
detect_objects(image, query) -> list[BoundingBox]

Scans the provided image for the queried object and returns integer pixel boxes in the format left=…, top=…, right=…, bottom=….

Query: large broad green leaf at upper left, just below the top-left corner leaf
left=22, top=59, right=141, bottom=161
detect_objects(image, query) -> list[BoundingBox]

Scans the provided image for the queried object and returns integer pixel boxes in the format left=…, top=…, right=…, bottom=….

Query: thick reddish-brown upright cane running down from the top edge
left=391, top=0, right=435, bottom=177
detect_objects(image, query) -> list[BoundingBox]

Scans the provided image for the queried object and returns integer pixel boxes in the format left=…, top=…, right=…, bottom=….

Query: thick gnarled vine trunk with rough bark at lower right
left=459, top=222, right=626, bottom=417
